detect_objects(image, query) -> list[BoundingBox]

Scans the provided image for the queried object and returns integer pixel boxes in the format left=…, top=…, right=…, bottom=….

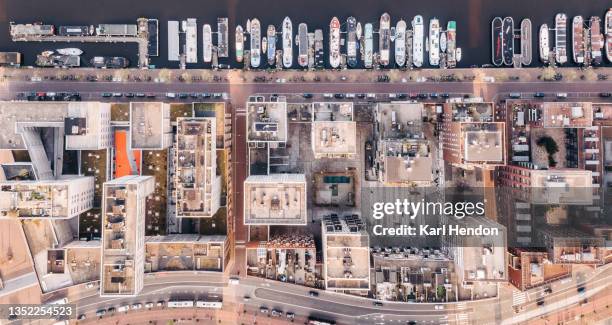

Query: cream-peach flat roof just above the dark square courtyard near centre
left=311, top=121, right=357, bottom=155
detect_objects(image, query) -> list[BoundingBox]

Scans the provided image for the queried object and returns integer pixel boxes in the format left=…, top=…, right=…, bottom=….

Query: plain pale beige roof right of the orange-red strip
left=130, top=102, right=172, bottom=149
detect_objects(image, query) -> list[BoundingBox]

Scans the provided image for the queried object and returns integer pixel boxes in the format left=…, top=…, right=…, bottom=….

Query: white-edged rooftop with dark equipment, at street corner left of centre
left=246, top=102, right=287, bottom=142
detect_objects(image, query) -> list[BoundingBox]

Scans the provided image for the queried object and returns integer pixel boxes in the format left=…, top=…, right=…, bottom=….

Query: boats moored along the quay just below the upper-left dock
left=36, top=47, right=130, bottom=69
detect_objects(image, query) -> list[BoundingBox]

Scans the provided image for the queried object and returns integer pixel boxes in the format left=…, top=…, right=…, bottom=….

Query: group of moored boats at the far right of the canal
left=491, top=8, right=612, bottom=66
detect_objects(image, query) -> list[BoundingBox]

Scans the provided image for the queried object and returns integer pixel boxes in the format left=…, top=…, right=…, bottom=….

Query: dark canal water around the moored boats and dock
left=0, top=0, right=612, bottom=67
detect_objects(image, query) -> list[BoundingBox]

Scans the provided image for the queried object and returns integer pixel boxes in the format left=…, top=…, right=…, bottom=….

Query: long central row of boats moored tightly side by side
left=237, top=13, right=461, bottom=69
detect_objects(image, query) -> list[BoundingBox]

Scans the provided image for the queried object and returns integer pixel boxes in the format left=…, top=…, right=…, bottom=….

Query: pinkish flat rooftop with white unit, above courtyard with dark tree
left=542, top=102, right=593, bottom=128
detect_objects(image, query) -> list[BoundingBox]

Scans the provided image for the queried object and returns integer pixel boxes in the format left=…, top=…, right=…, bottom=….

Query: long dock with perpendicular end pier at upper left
left=10, top=18, right=158, bottom=68
